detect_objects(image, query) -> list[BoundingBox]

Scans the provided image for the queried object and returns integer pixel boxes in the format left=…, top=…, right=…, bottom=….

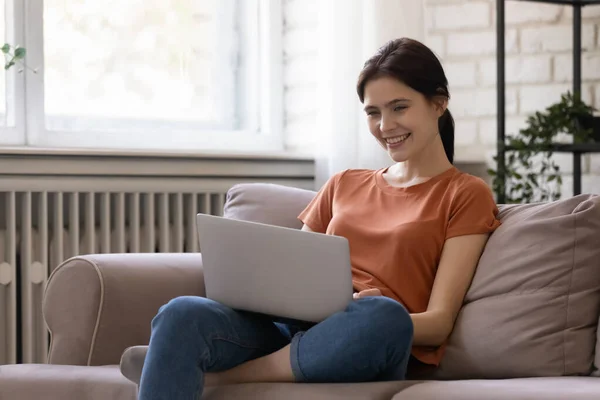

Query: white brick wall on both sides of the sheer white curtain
left=284, top=0, right=600, bottom=196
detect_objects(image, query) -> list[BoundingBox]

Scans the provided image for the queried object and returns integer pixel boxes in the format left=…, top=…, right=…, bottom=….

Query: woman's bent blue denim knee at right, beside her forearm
left=290, top=297, right=413, bottom=383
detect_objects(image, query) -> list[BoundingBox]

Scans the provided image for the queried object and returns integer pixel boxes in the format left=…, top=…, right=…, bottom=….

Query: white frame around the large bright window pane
left=14, top=0, right=284, bottom=152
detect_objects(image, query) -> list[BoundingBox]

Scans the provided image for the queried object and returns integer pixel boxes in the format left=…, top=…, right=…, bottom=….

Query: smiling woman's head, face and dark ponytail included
left=357, top=39, right=454, bottom=167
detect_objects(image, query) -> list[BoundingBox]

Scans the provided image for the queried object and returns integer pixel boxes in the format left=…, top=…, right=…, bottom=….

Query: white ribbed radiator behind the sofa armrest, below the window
left=0, top=150, right=314, bottom=365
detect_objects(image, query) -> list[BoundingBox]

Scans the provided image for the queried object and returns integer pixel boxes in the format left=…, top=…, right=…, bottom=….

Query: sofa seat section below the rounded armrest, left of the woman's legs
left=0, top=364, right=137, bottom=400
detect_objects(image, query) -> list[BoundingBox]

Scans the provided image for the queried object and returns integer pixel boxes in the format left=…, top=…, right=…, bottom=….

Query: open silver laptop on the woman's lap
left=197, top=214, right=353, bottom=322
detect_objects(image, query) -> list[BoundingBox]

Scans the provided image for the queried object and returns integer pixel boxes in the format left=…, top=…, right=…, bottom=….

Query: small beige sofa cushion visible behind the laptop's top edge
left=223, top=183, right=316, bottom=229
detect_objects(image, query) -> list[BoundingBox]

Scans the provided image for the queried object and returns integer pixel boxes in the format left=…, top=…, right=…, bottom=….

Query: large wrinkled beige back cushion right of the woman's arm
left=436, top=195, right=600, bottom=379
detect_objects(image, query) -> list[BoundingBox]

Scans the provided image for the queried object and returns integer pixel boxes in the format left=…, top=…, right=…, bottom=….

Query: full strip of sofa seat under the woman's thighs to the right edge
left=202, top=377, right=600, bottom=400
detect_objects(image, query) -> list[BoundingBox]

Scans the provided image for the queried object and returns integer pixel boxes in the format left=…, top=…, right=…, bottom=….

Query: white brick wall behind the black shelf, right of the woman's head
left=426, top=0, right=600, bottom=195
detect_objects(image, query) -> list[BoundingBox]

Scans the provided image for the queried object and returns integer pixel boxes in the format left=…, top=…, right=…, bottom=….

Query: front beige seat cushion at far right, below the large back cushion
left=392, top=376, right=600, bottom=400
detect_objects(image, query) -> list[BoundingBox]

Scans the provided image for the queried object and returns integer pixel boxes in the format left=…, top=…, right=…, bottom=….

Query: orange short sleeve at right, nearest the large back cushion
left=446, top=177, right=501, bottom=239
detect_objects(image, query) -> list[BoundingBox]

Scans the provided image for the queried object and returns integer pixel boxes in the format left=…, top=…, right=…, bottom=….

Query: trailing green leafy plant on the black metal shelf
left=488, top=92, right=594, bottom=204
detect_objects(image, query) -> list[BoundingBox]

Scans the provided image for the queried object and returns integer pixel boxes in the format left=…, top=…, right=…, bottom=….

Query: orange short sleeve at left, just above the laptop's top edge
left=298, top=171, right=345, bottom=233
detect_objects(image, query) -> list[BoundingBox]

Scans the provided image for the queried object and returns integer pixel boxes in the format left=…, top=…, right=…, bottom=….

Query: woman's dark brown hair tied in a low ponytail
left=356, top=38, right=454, bottom=163
